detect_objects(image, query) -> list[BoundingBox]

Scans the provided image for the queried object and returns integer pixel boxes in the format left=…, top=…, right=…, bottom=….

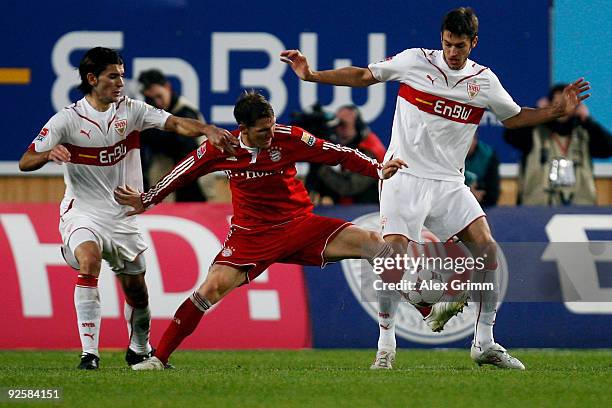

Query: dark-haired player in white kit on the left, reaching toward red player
left=19, top=47, right=237, bottom=369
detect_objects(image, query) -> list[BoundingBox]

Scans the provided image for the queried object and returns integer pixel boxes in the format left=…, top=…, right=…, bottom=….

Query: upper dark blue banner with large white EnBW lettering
left=0, top=0, right=549, bottom=162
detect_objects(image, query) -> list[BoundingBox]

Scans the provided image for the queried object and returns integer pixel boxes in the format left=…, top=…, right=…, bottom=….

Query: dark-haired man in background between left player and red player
left=138, top=69, right=206, bottom=202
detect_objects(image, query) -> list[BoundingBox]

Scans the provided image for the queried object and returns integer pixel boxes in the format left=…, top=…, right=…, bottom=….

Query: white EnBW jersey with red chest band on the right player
left=368, top=48, right=521, bottom=181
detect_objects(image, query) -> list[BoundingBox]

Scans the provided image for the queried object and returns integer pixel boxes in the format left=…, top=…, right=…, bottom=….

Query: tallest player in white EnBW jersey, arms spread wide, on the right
left=281, top=7, right=590, bottom=370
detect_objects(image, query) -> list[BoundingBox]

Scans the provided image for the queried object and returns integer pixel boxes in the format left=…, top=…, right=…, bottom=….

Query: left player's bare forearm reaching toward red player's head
left=164, top=115, right=238, bottom=153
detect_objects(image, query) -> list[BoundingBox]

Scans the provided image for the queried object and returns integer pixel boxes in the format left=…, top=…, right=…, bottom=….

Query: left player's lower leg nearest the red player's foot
left=117, top=262, right=153, bottom=366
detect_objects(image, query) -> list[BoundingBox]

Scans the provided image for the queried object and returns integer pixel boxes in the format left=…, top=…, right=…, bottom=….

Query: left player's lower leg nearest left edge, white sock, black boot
left=71, top=239, right=102, bottom=370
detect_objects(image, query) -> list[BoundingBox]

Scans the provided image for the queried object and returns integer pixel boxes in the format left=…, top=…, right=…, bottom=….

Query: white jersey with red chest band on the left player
left=30, top=96, right=170, bottom=232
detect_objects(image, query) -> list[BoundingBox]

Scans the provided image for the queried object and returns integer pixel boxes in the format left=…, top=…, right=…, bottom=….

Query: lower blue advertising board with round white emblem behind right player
left=305, top=206, right=612, bottom=348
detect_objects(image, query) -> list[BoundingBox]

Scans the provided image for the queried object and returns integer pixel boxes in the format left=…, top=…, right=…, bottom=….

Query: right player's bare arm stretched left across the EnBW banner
left=280, top=50, right=379, bottom=87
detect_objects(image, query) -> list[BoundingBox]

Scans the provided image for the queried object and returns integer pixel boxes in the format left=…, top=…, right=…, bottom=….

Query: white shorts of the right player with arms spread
left=380, top=173, right=485, bottom=242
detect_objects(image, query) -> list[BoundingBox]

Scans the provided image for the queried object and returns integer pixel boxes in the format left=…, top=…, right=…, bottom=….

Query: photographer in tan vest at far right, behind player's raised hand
left=504, top=84, right=612, bottom=206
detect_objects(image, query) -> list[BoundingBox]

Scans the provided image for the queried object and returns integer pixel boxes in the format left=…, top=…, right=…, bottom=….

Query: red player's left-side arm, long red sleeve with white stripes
left=114, top=141, right=220, bottom=215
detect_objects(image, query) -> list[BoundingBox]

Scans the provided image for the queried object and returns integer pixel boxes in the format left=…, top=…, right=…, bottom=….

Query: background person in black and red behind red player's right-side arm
left=296, top=105, right=385, bottom=205
